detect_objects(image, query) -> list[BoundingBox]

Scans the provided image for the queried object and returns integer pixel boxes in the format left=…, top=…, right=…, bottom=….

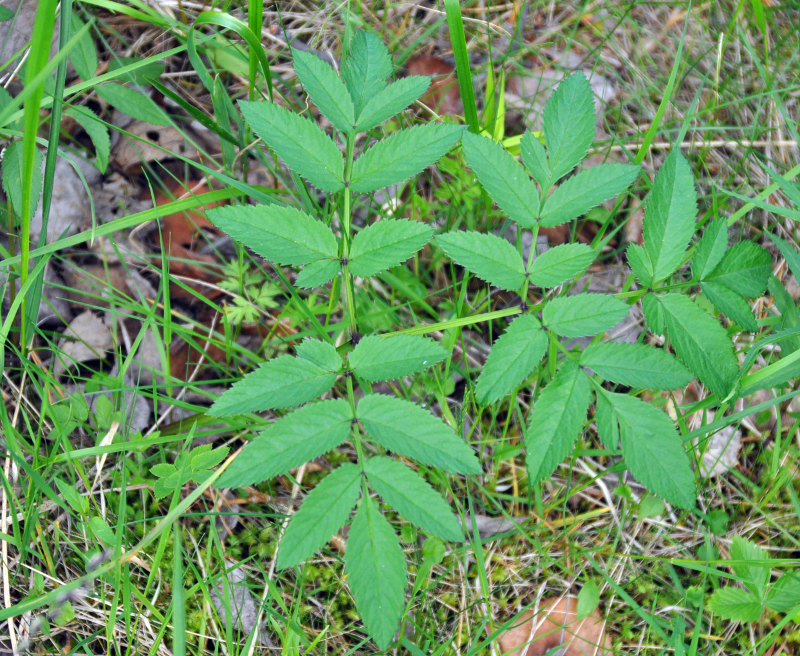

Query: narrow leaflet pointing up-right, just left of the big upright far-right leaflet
left=541, top=164, right=639, bottom=228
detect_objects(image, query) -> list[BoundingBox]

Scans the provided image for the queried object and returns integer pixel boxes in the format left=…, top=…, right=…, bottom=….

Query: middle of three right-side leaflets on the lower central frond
left=356, top=394, right=481, bottom=474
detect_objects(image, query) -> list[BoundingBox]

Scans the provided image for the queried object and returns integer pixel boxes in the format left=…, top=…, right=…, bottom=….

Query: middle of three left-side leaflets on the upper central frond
left=239, top=100, right=344, bottom=193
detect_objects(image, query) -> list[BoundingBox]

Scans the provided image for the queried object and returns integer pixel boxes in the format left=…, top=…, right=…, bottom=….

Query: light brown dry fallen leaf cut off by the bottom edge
left=498, top=595, right=612, bottom=656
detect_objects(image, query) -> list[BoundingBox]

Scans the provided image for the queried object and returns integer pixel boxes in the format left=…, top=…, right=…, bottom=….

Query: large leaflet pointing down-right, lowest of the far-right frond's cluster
left=645, top=294, right=739, bottom=399
